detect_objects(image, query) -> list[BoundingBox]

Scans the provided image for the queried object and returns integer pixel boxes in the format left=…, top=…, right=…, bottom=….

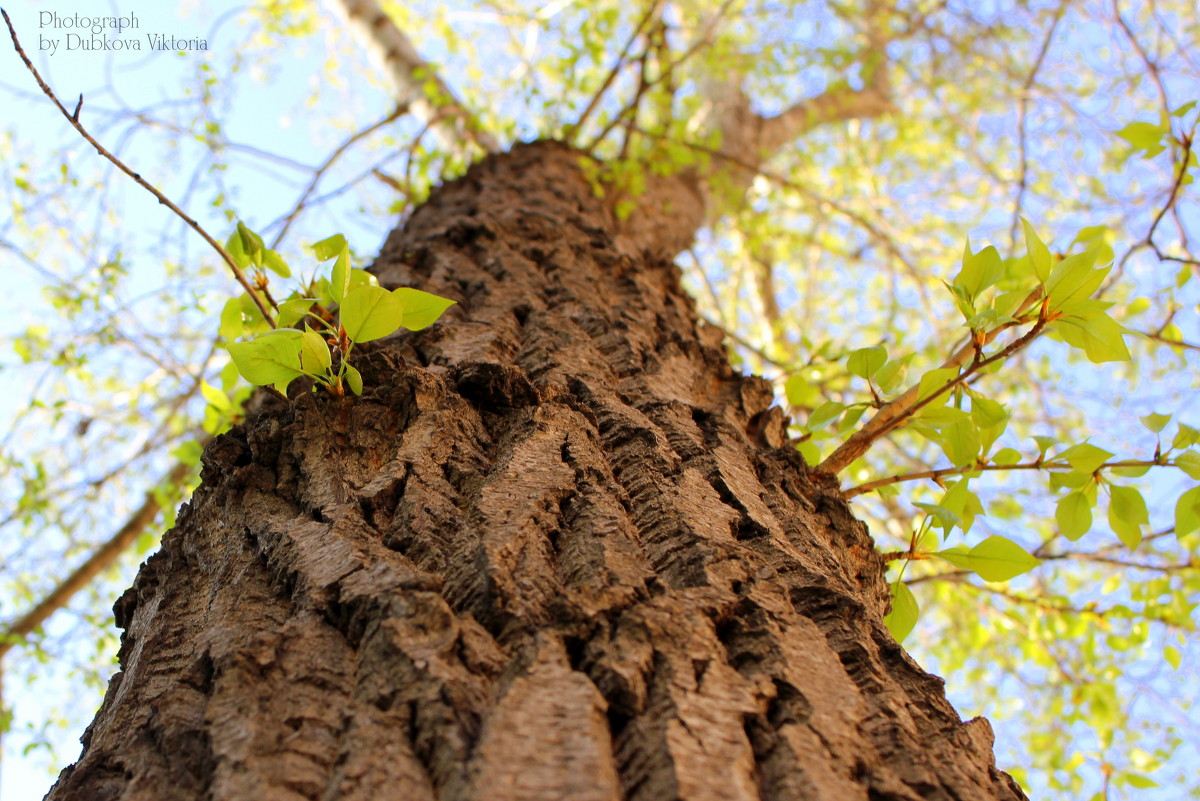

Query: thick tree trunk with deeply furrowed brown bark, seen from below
left=48, top=143, right=1024, bottom=801
